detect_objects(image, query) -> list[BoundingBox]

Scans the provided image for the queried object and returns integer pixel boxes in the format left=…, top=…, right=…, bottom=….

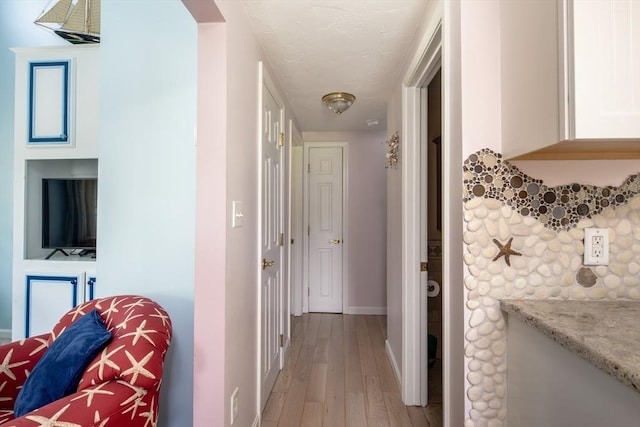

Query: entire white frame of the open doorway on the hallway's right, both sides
left=401, top=1, right=465, bottom=427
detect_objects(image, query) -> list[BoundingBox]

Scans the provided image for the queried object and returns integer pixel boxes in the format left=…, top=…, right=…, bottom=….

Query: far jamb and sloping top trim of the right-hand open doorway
left=400, top=15, right=447, bottom=405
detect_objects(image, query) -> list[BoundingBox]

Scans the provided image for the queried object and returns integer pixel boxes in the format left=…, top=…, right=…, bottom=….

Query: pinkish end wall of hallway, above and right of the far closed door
left=303, top=131, right=387, bottom=311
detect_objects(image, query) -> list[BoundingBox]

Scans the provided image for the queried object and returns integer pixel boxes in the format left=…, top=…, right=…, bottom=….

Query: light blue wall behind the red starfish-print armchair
left=97, top=0, right=197, bottom=427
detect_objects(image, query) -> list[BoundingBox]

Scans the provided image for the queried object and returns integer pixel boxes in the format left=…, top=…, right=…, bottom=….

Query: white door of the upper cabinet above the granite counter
left=567, top=0, right=640, bottom=139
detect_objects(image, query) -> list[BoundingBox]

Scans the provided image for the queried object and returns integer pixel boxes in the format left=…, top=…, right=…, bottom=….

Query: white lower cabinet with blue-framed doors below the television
left=19, top=272, right=96, bottom=339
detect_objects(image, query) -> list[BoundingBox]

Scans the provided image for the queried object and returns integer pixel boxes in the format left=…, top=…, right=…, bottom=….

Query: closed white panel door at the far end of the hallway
left=308, top=147, right=344, bottom=313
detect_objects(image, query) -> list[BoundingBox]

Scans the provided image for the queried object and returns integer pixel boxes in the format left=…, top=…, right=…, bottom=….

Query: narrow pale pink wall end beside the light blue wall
left=193, top=23, right=227, bottom=425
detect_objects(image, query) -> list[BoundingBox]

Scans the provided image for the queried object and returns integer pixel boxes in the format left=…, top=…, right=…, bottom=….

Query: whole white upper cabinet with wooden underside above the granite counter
left=500, top=0, right=640, bottom=159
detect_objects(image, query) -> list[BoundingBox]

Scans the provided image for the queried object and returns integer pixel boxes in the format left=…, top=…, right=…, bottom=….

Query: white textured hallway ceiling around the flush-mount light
left=241, top=0, right=429, bottom=131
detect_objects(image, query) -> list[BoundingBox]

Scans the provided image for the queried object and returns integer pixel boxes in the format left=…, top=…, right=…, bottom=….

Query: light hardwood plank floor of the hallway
left=261, top=313, right=442, bottom=427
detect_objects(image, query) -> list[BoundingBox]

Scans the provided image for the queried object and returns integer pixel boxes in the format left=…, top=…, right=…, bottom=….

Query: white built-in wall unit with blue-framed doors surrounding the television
left=11, top=45, right=100, bottom=340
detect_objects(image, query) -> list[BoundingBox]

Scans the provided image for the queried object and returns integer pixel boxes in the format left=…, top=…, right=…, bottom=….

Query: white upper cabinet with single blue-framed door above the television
left=12, top=45, right=100, bottom=160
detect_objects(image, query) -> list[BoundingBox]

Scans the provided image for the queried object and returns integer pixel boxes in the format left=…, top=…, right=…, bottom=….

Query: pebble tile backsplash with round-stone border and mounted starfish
left=463, top=149, right=640, bottom=427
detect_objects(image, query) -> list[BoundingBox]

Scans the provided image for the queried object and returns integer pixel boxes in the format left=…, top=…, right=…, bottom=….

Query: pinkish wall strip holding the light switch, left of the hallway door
left=218, top=2, right=262, bottom=426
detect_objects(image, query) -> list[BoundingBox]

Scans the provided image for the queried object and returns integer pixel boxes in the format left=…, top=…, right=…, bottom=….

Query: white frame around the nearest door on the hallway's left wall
left=255, top=61, right=287, bottom=414
